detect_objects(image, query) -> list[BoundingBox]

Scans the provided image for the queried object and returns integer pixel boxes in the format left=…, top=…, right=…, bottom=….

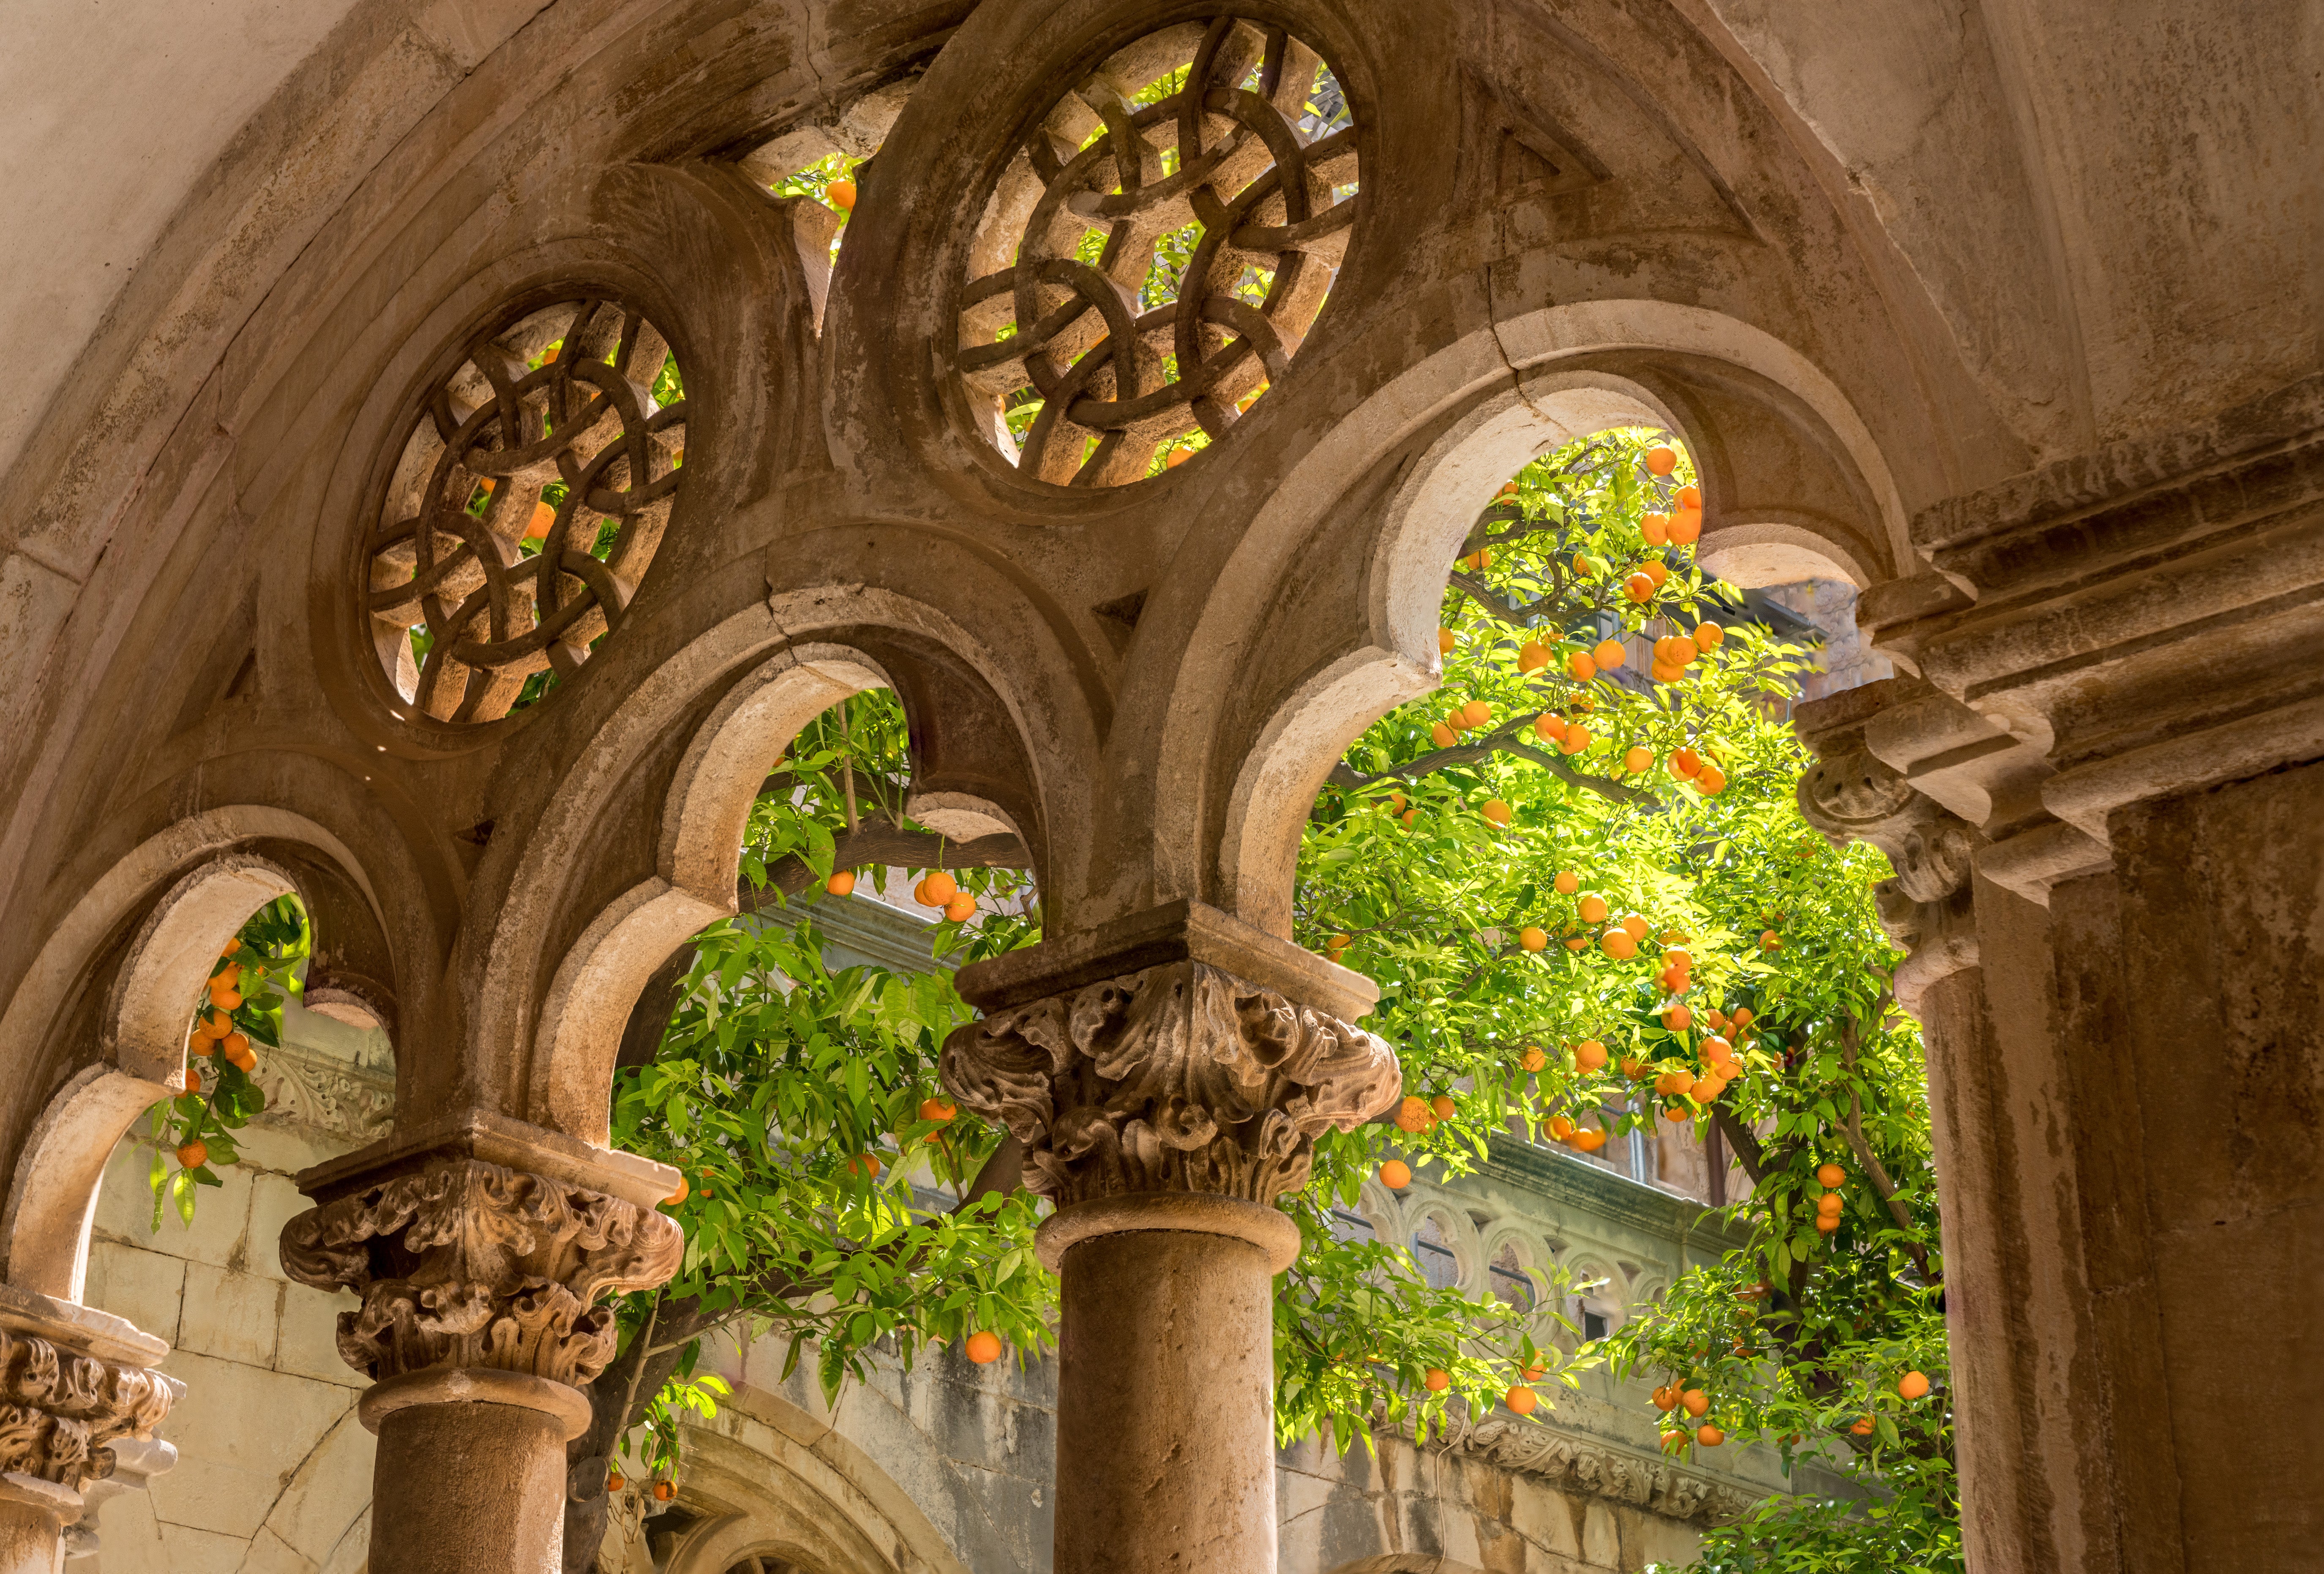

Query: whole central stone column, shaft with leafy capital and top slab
left=944, top=902, right=1402, bottom=1574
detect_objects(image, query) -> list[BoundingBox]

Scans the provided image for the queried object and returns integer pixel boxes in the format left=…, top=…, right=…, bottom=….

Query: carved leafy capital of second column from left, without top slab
left=281, top=1158, right=686, bottom=1388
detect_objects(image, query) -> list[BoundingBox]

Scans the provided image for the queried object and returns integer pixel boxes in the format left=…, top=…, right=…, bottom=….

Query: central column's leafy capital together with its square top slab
left=941, top=902, right=1402, bottom=1206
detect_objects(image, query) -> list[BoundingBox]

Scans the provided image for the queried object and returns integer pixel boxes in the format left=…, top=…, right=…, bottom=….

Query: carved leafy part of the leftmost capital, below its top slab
left=0, top=1328, right=184, bottom=1492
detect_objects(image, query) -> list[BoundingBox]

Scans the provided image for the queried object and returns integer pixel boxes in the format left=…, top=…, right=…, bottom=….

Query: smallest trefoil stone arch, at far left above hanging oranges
left=0, top=804, right=379, bottom=1302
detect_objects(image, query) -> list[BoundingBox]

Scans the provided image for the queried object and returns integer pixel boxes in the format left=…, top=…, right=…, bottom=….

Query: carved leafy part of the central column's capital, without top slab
left=941, top=960, right=1402, bottom=1204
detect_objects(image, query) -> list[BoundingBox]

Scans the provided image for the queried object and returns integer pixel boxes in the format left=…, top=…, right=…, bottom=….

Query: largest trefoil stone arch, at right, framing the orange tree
left=1199, top=300, right=1910, bottom=934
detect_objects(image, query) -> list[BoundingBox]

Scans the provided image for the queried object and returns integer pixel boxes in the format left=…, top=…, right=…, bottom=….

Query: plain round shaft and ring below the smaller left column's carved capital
left=360, top=1370, right=588, bottom=1574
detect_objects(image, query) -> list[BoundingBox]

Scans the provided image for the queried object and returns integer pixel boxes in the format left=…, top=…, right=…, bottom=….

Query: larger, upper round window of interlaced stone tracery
left=957, top=16, right=1357, bottom=486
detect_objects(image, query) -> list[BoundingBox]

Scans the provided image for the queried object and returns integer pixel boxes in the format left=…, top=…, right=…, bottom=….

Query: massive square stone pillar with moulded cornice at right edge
left=1801, top=379, right=2324, bottom=1574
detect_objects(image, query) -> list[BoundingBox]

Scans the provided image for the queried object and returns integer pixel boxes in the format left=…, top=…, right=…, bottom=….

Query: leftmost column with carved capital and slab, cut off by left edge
left=0, top=1286, right=184, bottom=1574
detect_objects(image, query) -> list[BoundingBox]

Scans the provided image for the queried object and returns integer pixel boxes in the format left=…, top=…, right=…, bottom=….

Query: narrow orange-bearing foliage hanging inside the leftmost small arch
left=147, top=895, right=314, bottom=1230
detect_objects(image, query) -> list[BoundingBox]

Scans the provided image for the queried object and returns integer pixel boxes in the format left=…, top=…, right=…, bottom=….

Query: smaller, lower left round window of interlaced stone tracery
left=365, top=300, right=686, bottom=721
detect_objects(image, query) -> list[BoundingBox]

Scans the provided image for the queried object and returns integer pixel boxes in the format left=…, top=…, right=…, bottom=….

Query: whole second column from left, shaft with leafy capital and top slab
left=281, top=1114, right=683, bottom=1574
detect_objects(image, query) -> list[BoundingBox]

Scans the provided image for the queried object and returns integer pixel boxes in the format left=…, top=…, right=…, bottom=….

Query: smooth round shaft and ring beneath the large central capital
left=1041, top=1193, right=1299, bottom=1574
